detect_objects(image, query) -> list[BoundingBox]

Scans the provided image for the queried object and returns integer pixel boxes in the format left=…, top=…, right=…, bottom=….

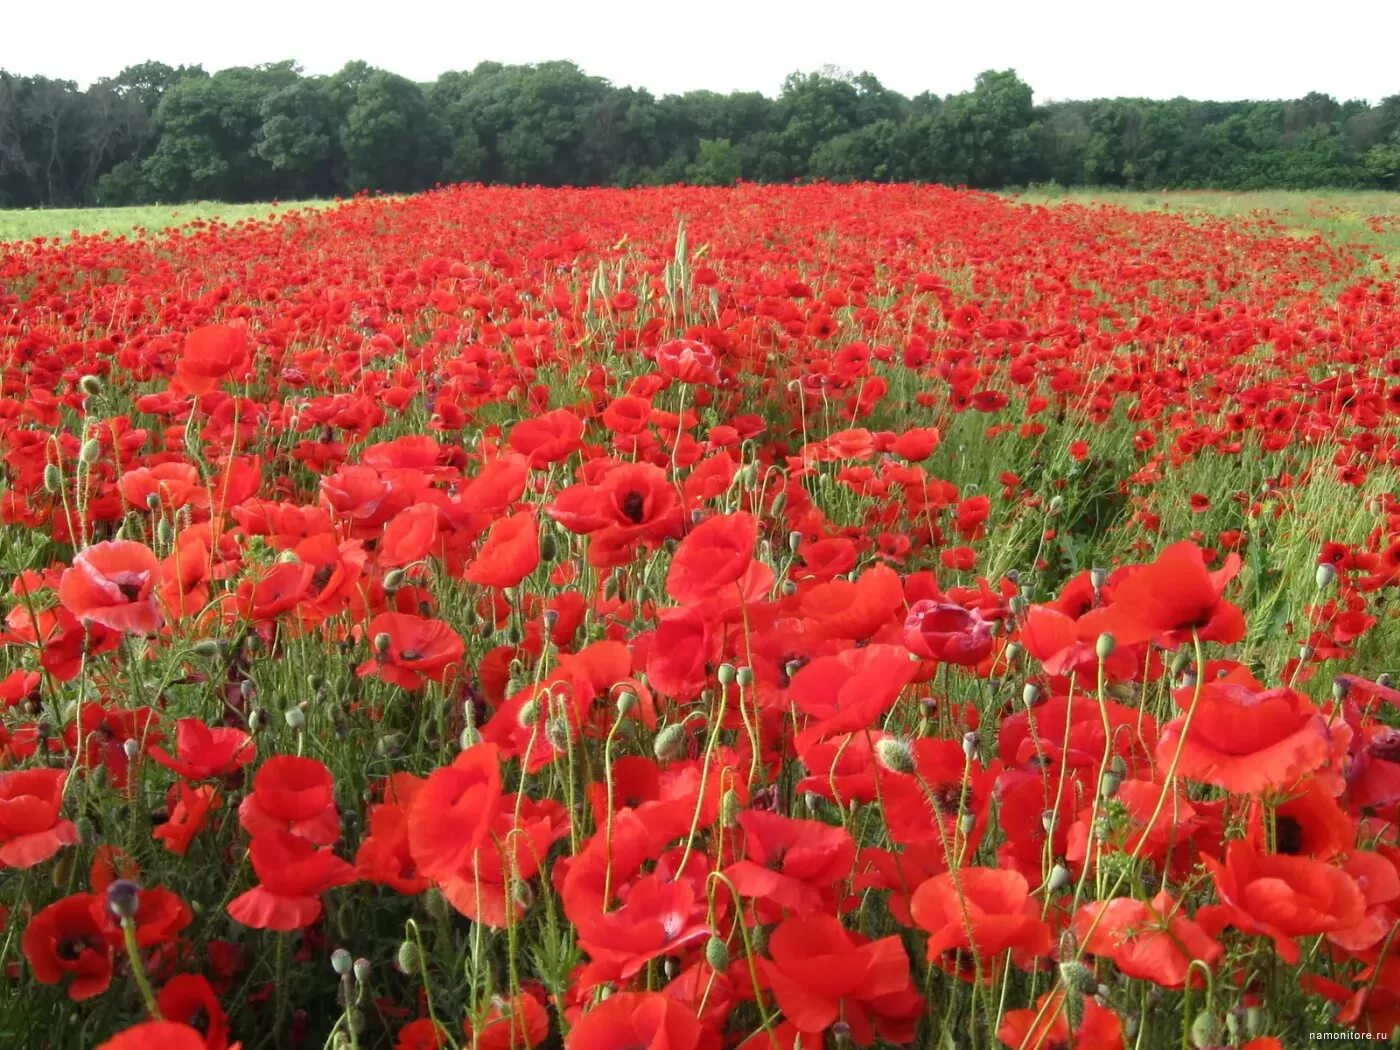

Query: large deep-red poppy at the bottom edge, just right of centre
left=760, top=914, right=924, bottom=1046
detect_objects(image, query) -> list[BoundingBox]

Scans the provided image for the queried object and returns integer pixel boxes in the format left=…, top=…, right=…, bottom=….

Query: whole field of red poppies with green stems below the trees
left=0, top=185, right=1400, bottom=1050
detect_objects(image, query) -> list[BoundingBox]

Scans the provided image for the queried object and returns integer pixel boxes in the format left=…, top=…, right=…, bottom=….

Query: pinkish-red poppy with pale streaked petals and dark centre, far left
left=59, top=539, right=161, bottom=634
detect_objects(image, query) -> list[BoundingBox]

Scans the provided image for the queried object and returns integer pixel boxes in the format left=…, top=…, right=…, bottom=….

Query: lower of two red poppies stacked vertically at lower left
left=228, top=830, right=354, bottom=930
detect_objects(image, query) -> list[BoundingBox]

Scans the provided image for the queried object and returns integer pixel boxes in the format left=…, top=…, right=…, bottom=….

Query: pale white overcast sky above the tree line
left=0, top=0, right=1400, bottom=102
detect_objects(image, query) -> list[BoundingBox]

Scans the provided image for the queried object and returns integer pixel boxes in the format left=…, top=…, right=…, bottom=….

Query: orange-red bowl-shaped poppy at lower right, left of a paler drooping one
left=910, top=868, right=1050, bottom=981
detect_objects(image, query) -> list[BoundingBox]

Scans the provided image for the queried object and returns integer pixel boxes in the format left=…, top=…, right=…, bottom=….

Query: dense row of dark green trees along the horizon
left=0, top=62, right=1400, bottom=207
